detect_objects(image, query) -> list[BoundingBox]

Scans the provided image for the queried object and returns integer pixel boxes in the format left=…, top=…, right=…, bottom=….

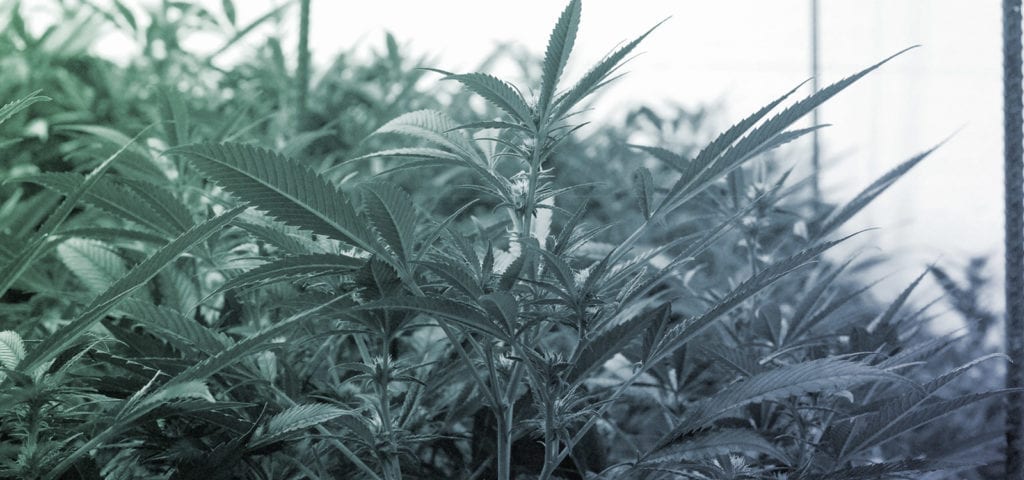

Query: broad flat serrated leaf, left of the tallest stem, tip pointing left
left=168, top=143, right=378, bottom=253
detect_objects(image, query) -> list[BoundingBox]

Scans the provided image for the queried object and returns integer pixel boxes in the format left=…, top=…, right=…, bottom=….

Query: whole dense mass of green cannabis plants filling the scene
left=0, top=0, right=1004, bottom=479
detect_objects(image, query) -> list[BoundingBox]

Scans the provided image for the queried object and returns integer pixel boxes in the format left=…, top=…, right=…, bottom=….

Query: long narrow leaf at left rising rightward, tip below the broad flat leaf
left=19, top=203, right=245, bottom=372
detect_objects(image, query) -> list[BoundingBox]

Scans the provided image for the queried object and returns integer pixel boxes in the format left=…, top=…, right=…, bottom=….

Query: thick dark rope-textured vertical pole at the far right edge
left=1002, top=0, right=1024, bottom=474
